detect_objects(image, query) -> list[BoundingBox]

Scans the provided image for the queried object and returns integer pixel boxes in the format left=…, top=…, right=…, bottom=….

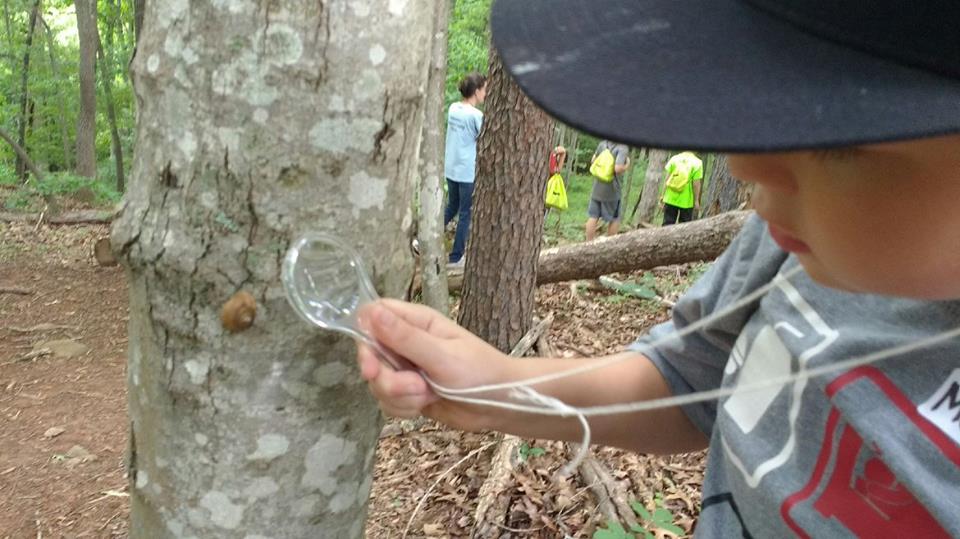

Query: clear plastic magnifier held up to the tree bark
left=280, top=233, right=417, bottom=371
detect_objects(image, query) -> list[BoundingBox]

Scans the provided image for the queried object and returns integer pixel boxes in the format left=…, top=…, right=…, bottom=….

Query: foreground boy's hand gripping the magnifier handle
left=357, top=300, right=509, bottom=430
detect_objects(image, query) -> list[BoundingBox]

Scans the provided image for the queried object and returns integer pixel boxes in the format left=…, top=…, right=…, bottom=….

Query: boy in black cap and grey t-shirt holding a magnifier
left=358, top=0, right=960, bottom=537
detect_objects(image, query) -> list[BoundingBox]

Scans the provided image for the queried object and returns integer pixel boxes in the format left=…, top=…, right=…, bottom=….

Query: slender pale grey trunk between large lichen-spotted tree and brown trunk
left=417, top=0, right=453, bottom=314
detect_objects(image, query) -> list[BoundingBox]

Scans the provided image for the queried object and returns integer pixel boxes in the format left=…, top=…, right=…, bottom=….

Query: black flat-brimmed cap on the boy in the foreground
left=491, top=0, right=960, bottom=152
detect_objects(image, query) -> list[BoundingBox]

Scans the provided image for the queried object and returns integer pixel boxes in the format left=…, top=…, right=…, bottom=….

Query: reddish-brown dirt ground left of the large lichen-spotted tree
left=0, top=226, right=127, bottom=538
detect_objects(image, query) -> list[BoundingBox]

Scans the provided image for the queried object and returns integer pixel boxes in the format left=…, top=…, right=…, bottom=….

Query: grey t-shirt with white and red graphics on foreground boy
left=632, top=217, right=960, bottom=538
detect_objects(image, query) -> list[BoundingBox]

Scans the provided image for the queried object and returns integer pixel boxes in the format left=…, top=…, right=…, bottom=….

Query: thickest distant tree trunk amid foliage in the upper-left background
left=74, top=0, right=97, bottom=178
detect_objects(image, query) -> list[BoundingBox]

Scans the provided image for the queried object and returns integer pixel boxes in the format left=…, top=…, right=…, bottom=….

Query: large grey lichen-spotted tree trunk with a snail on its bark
left=112, top=0, right=435, bottom=538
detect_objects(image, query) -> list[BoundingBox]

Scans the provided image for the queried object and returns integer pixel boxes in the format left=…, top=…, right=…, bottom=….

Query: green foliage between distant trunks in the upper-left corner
left=0, top=0, right=135, bottom=192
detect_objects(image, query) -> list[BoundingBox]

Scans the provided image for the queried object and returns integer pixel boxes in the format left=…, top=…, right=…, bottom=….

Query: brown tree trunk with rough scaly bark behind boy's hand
left=460, top=47, right=553, bottom=352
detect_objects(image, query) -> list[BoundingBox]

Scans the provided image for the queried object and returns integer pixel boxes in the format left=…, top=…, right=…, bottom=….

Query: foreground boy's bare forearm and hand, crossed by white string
left=358, top=300, right=706, bottom=458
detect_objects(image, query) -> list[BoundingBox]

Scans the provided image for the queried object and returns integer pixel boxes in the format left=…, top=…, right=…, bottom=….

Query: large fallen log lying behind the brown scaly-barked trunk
left=448, top=211, right=752, bottom=290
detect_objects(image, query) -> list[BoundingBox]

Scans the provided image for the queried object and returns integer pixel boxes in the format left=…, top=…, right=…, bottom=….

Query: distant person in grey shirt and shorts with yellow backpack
left=586, top=140, right=630, bottom=241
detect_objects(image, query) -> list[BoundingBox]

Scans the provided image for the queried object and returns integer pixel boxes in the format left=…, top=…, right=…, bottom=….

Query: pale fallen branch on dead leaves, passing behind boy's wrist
left=470, top=314, right=553, bottom=539
